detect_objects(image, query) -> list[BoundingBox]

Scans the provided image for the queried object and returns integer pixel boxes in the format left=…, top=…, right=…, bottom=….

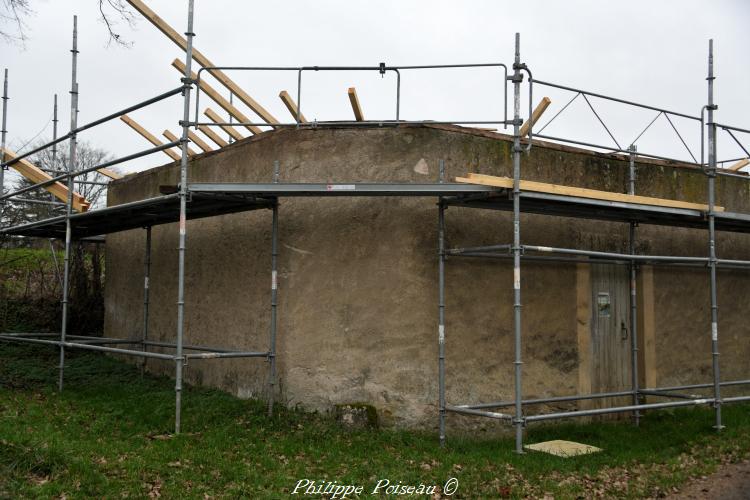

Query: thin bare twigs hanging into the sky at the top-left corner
left=0, top=0, right=135, bottom=47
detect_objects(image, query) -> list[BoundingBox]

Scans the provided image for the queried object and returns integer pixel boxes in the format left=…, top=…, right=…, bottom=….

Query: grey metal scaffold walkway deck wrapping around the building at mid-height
left=0, top=182, right=750, bottom=240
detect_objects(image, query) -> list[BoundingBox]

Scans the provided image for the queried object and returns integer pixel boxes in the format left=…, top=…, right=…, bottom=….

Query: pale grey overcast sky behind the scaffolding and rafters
left=0, top=0, right=750, bottom=182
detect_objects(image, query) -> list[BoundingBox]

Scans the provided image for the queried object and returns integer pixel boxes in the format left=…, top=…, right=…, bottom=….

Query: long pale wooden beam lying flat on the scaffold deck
left=456, top=174, right=724, bottom=212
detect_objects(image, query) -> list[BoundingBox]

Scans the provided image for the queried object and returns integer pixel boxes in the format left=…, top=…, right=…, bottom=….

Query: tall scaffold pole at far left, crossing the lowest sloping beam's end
left=57, top=16, right=78, bottom=391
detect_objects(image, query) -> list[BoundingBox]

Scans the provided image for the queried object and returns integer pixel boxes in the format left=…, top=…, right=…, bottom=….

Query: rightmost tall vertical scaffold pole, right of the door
left=707, top=40, right=723, bottom=431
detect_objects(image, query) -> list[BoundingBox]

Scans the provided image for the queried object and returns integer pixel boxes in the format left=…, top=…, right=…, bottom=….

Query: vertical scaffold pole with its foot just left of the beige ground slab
left=511, top=33, right=530, bottom=453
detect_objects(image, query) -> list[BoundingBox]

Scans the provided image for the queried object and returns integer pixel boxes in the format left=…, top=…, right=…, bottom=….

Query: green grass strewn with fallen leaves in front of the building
left=0, top=344, right=750, bottom=498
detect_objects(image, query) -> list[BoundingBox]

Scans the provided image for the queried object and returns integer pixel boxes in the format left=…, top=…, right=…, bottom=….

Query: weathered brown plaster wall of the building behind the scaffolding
left=106, top=126, right=750, bottom=427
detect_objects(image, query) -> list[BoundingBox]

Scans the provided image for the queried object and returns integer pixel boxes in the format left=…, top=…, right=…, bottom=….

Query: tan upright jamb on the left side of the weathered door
left=576, top=263, right=593, bottom=409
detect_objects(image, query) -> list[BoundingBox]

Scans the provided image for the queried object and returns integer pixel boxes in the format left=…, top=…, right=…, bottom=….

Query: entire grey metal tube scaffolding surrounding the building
left=0, top=0, right=750, bottom=453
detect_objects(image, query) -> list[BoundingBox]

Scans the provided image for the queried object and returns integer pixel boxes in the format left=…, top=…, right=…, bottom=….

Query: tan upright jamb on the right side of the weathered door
left=637, top=266, right=658, bottom=387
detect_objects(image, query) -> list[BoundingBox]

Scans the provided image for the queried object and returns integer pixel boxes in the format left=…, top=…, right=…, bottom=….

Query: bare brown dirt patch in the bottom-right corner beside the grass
left=667, top=460, right=750, bottom=500
